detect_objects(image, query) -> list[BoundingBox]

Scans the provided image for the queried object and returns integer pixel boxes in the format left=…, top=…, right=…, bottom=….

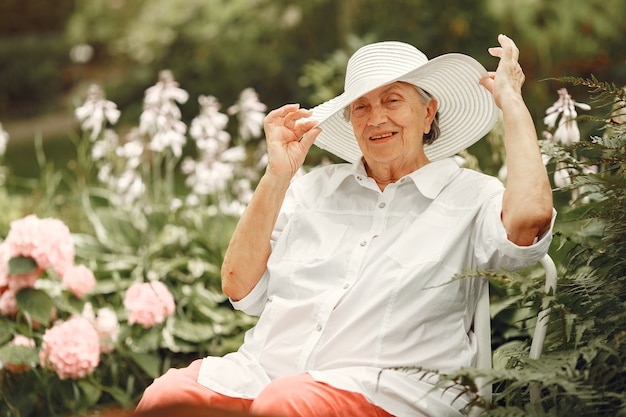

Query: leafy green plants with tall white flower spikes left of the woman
left=0, top=71, right=264, bottom=417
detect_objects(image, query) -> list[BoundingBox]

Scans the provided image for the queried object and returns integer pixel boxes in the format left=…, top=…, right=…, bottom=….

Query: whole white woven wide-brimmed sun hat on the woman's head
left=310, top=41, right=499, bottom=163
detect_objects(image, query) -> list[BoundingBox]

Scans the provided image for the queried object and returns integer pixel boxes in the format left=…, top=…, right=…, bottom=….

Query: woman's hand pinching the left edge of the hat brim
left=263, top=104, right=322, bottom=178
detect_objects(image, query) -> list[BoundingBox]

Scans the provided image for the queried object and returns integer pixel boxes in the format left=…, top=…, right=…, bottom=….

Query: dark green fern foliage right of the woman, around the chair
left=448, top=78, right=626, bottom=417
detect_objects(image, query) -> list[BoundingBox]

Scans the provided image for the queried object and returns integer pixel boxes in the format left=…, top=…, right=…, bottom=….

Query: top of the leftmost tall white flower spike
left=74, top=84, right=120, bottom=141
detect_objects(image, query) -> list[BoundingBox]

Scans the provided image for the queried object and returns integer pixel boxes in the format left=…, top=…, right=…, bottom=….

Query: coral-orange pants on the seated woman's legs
left=136, top=359, right=392, bottom=417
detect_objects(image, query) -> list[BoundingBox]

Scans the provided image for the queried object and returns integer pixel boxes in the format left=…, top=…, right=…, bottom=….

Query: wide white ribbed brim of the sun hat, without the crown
left=310, top=53, right=499, bottom=163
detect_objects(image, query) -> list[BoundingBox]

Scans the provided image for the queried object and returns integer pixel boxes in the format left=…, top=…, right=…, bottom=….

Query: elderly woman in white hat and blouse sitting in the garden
left=138, top=35, right=554, bottom=417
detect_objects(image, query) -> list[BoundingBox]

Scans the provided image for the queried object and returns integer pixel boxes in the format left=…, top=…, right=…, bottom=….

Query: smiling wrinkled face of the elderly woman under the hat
left=350, top=82, right=437, bottom=173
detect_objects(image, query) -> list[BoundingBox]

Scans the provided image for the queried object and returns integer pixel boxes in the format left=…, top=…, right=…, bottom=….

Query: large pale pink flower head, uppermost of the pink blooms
left=5, top=214, right=74, bottom=276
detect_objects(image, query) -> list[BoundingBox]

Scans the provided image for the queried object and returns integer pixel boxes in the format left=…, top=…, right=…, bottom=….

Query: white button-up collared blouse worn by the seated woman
left=198, top=159, right=554, bottom=417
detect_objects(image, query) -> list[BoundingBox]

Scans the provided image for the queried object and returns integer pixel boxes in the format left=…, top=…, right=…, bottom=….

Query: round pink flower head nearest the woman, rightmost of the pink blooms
left=124, top=281, right=176, bottom=329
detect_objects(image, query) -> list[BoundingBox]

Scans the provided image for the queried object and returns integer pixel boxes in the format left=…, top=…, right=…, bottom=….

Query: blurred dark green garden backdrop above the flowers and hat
left=0, top=0, right=626, bottom=175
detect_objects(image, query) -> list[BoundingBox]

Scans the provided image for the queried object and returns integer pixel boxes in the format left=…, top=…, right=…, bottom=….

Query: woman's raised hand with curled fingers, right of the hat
left=480, top=35, right=526, bottom=108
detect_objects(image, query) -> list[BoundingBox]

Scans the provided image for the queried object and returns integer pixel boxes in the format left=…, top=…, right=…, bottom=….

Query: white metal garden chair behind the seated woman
left=468, top=255, right=556, bottom=417
